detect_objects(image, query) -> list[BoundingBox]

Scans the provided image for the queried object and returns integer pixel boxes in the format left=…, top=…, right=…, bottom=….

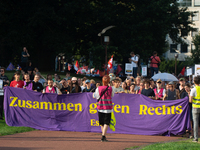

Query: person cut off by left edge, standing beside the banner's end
left=0, top=67, right=9, bottom=120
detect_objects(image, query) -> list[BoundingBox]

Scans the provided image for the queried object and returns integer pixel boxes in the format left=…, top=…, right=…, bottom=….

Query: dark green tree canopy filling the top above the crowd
left=0, top=0, right=193, bottom=70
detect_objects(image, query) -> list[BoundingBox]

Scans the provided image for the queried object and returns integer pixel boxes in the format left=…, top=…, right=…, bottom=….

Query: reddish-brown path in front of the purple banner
left=0, top=131, right=184, bottom=150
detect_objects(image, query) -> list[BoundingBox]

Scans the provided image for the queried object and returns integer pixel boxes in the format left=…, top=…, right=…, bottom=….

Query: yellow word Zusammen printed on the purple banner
left=9, top=96, right=82, bottom=111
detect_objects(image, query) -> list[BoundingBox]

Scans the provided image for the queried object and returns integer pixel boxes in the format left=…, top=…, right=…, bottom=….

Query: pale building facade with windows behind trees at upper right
left=165, top=0, right=200, bottom=61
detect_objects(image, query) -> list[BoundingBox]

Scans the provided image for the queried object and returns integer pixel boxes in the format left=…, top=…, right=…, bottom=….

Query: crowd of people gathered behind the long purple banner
left=0, top=48, right=200, bottom=142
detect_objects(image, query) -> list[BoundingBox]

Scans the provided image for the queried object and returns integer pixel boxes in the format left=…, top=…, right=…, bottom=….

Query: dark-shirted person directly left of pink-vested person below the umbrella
left=141, top=80, right=155, bottom=99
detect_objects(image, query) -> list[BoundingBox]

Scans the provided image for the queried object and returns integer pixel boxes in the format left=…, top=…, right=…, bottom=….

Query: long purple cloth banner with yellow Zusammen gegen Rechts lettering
left=4, top=87, right=191, bottom=135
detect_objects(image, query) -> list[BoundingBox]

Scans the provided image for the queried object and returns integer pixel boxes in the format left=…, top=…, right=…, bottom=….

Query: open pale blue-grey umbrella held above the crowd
left=152, top=73, right=178, bottom=81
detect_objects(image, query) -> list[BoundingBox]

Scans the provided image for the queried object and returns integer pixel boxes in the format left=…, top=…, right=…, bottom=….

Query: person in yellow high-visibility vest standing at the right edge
left=189, top=77, right=200, bottom=142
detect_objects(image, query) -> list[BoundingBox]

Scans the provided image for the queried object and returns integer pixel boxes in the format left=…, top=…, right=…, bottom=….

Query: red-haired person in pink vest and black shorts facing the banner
left=93, top=75, right=114, bottom=142
